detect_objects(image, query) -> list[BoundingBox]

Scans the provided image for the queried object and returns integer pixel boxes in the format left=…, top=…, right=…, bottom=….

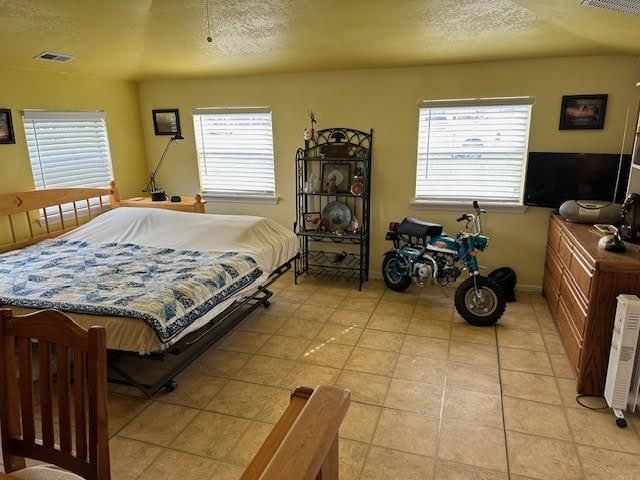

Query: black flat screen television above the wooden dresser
left=524, top=152, right=631, bottom=208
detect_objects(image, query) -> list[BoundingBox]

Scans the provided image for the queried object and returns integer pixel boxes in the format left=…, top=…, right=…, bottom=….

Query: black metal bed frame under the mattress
left=107, top=255, right=298, bottom=398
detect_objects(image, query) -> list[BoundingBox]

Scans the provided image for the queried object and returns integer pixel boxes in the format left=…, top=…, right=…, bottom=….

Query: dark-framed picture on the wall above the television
left=560, top=94, right=609, bottom=130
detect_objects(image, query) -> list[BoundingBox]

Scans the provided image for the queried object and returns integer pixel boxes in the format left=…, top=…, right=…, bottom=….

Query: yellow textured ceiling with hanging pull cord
left=0, top=0, right=640, bottom=79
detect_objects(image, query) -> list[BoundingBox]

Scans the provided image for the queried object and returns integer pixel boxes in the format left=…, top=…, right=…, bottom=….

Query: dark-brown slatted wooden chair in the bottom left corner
left=0, top=309, right=110, bottom=480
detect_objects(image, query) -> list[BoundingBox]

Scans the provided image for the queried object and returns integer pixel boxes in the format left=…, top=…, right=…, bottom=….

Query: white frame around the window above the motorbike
left=411, top=96, right=535, bottom=211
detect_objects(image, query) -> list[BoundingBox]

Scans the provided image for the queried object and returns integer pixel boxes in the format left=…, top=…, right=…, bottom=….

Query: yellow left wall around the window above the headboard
left=0, top=68, right=146, bottom=195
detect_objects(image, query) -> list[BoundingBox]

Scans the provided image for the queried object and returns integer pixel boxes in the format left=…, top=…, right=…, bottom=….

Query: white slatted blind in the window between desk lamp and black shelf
left=193, top=108, right=275, bottom=197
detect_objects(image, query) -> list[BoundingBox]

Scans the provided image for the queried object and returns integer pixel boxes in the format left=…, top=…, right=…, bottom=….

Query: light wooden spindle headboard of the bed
left=0, top=181, right=120, bottom=253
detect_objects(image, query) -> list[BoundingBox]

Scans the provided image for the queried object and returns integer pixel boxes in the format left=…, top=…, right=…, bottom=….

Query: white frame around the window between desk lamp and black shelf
left=193, top=106, right=280, bottom=205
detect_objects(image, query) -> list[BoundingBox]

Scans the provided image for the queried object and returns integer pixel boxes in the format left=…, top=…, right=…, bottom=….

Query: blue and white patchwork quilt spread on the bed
left=0, top=240, right=263, bottom=343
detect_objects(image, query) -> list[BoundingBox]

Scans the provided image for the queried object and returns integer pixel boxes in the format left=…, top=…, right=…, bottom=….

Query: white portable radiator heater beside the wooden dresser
left=604, top=295, right=640, bottom=428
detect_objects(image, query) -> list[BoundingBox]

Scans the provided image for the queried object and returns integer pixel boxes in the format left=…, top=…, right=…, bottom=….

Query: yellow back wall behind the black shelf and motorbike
left=140, top=53, right=640, bottom=286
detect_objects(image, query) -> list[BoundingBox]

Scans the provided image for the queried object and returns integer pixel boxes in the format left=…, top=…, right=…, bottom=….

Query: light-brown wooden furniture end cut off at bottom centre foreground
left=240, top=385, right=350, bottom=480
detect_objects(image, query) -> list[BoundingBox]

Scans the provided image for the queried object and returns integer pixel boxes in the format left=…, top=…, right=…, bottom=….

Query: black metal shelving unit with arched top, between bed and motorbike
left=294, top=128, right=373, bottom=289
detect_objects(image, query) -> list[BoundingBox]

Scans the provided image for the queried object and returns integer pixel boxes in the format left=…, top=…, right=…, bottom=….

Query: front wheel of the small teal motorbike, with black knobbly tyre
left=455, top=275, right=507, bottom=327
